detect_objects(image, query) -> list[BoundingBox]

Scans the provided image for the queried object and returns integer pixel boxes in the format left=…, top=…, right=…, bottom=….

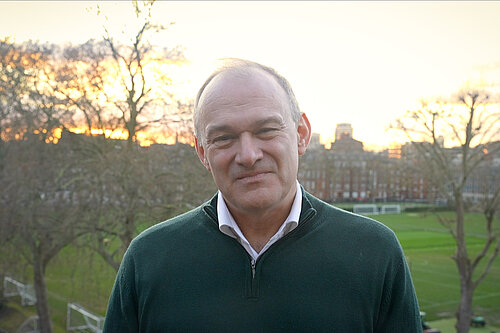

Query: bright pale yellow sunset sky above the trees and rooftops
left=0, top=1, right=500, bottom=149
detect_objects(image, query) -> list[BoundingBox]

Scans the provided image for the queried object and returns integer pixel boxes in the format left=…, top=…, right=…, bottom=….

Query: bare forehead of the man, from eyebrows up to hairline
left=199, top=69, right=291, bottom=131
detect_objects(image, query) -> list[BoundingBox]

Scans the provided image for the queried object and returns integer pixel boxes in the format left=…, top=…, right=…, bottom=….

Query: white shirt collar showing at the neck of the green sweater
left=217, top=181, right=302, bottom=261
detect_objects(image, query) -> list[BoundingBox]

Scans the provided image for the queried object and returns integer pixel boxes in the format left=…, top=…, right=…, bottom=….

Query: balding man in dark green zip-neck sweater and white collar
left=104, top=60, right=422, bottom=333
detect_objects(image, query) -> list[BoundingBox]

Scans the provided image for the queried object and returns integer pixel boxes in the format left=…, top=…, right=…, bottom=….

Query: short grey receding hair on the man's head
left=193, top=58, right=301, bottom=138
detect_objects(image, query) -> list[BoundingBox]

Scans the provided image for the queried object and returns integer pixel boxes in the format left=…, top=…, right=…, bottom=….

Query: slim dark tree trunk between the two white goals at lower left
left=33, top=255, right=52, bottom=333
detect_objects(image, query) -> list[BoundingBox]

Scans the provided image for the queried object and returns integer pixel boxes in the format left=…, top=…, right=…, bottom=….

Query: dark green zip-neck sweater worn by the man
left=104, top=192, right=422, bottom=333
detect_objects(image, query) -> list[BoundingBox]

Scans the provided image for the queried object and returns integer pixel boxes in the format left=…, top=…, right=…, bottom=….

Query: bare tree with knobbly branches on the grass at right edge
left=393, top=89, right=500, bottom=333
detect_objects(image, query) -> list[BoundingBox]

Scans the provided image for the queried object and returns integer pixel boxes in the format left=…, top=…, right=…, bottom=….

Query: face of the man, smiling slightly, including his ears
left=196, top=70, right=310, bottom=215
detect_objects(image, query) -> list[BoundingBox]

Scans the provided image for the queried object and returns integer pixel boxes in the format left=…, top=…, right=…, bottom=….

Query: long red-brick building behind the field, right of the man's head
left=298, top=124, right=500, bottom=202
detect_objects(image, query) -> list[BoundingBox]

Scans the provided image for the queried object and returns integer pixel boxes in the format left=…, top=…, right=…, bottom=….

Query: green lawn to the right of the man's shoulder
left=375, top=213, right=500, bottom=326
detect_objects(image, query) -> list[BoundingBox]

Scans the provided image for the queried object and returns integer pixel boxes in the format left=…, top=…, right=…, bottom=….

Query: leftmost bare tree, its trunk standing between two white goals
left=2, top=138, right=91, bottom=332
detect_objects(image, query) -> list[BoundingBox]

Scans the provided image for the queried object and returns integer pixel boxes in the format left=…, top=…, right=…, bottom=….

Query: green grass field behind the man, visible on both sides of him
left=0, top=213, right=500, bottom=333
